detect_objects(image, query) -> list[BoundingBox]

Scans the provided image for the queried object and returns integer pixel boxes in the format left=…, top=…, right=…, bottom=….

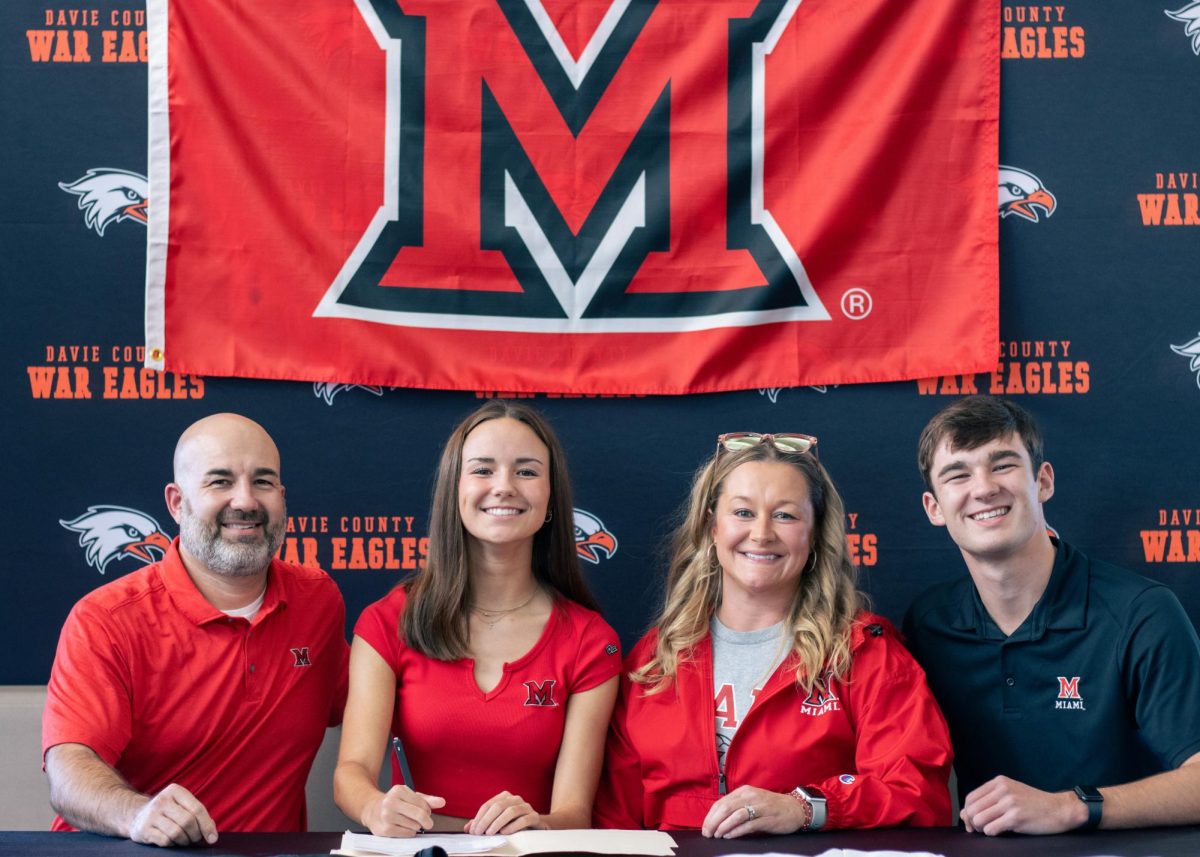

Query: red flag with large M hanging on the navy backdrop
left=146, top=0, right=1000, bottom=394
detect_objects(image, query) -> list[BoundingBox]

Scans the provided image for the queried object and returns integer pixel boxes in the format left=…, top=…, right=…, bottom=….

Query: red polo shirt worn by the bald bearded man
left=42, top=539, right=349, bottom=831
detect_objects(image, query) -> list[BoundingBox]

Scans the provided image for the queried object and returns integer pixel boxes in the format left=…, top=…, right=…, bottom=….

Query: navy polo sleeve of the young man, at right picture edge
left=1122, top=586, right=1200, bottom=768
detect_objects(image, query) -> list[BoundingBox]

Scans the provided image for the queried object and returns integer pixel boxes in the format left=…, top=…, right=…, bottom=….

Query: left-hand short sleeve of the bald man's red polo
left=42, top=598, right=133, bottom=767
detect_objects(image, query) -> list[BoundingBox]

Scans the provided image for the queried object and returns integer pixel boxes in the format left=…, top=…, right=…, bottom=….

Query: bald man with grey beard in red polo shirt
left=42, top=414, right=348, bottom=845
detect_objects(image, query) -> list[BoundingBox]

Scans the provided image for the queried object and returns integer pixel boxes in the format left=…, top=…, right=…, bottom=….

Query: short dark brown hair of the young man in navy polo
left=917, top=396, right=1045, bottom=491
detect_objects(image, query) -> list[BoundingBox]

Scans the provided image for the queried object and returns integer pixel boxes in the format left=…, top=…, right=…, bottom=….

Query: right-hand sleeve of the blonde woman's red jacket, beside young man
left=814, top=617, right=954, bottom=828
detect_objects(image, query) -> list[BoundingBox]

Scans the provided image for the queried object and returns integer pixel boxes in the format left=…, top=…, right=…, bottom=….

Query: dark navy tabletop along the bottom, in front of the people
left=0, top=827, right=1200, bottom=857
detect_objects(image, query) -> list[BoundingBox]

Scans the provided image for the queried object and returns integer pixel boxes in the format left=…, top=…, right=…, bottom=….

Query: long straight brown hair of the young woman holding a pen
left=400, top=398, right=599, bottom=660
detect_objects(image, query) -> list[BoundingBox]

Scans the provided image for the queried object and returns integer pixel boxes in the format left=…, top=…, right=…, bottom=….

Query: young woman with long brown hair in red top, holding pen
left=334, top=400, right=620, bottom=837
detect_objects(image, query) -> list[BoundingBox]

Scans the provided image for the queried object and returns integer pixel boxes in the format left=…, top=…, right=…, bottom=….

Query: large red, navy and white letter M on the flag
left=314, top=0, right=829, bottom=332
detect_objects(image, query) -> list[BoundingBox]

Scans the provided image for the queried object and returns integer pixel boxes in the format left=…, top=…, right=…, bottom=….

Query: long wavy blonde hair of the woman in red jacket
left=630, top=443, right=865, bottom=694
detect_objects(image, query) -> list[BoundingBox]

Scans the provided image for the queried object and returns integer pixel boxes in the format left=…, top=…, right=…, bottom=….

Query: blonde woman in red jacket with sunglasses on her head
left=596, top=432, right=952, bottom=838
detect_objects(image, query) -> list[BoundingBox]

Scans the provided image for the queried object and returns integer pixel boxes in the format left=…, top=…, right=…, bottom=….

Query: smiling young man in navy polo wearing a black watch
left=905, top=396, right=1200, bottom=835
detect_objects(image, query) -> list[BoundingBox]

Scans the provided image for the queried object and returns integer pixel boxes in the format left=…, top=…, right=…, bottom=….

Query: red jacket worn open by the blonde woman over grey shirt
left=595, top=612, right=953, bottom=829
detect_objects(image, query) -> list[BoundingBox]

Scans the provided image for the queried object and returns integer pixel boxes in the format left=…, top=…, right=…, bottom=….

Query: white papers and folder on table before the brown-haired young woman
left=330, top=831, right=676, bottom=857
